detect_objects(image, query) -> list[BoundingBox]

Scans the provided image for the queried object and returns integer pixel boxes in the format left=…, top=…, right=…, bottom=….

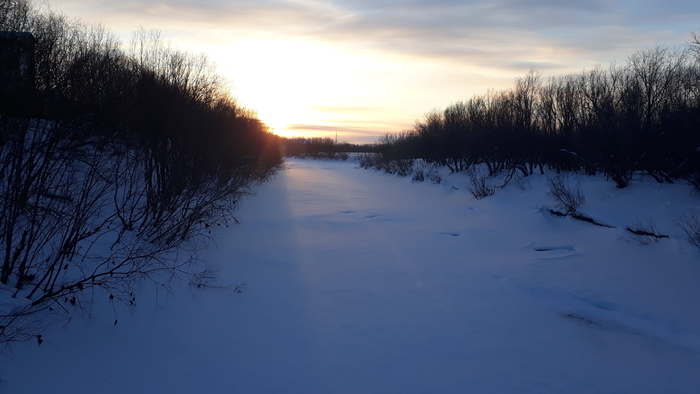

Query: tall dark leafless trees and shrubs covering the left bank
left=0, top=0, right=281, bottom=342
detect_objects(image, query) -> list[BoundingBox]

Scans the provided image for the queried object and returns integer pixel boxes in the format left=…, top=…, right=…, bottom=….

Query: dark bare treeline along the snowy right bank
left=370, top=40, right=700, bottom=187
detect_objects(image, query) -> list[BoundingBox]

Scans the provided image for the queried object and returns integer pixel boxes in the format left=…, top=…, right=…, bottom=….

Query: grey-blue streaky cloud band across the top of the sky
left=58, top=0, right=700, bottom=71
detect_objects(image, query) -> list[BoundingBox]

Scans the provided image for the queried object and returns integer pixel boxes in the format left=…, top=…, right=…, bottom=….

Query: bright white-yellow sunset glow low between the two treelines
left=178, top=30, right=520, bottom=142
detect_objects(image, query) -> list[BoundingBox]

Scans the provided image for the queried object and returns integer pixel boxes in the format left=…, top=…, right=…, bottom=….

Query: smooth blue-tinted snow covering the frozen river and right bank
left=0, top=160, right=700, bottom=393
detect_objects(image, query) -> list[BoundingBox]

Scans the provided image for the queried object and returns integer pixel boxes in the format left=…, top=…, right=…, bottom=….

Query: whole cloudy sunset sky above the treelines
left=48, top=0, right=700, bottom=143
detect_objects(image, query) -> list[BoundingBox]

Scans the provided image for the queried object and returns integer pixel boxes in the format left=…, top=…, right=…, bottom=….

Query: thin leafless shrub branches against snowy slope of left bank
left=0, top=121, right=252, bottom=342
